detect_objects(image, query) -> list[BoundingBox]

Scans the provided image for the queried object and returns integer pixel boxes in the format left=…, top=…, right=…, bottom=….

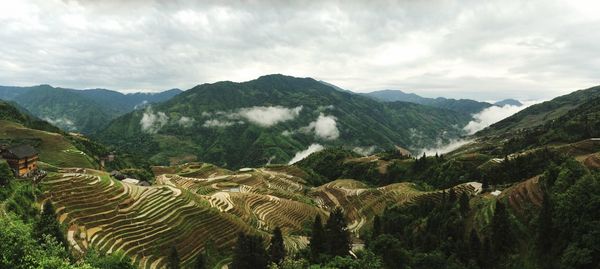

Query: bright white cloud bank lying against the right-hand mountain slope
left=463, top=101, right=539, bottom=134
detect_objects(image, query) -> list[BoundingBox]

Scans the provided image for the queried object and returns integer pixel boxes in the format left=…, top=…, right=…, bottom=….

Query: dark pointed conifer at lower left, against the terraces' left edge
left=34, top=200, right=69, bottom=250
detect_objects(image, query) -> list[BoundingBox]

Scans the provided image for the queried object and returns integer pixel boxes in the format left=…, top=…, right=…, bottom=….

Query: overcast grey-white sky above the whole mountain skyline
left=0, top=0, right=600, bottom=100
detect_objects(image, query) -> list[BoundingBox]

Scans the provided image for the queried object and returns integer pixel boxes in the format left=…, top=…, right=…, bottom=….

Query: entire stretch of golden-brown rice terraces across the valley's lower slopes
left=41, top=164, right=481, bottom=268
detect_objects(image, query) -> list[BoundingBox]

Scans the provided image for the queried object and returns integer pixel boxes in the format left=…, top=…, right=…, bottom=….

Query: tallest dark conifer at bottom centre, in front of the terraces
left=325, top=207, right=351, bottom=256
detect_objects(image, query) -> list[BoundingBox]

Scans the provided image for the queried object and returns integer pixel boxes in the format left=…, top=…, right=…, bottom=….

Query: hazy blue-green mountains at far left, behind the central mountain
left=0, top=85, right=181, bottom=134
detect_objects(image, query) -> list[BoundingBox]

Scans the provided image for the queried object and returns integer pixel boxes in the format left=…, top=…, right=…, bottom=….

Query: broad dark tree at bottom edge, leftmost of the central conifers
left=231, top=233, right=269, bottom=269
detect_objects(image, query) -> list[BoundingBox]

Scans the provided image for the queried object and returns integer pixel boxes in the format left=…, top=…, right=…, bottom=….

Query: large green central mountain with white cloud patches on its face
left=95, top=75, right=471, bottom=168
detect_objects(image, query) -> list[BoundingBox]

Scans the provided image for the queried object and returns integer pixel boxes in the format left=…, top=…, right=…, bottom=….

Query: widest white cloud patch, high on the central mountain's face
left=232, top=106, right=302, bottom=127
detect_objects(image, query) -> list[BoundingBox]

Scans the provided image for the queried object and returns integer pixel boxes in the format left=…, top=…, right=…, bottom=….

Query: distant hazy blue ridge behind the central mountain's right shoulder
left=365, top=90, right=492, bottom=114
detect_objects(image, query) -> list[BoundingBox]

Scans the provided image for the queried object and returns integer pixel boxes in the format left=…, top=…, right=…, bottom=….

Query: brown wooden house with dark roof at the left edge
left=0, top=145, right=38, bottom=177
